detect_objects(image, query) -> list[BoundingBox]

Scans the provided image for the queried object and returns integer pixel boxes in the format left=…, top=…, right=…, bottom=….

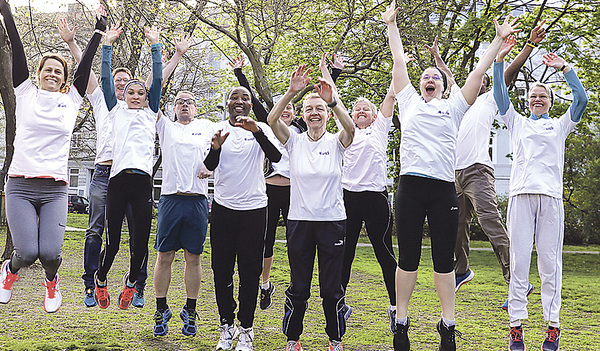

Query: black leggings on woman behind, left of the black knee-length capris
left=342, top=189, right=397, bottom=306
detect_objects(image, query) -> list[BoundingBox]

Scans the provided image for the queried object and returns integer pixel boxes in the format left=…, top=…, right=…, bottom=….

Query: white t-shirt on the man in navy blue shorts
left=156, top=116, right=214, bottom=196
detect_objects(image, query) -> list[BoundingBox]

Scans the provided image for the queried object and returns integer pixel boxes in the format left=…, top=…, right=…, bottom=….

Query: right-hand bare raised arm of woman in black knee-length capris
left=461, top=15, right=520, bottom=105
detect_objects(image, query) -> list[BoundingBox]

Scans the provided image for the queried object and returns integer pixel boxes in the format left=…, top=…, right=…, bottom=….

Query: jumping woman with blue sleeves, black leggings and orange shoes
left=94, top=27, right=162, bottom=309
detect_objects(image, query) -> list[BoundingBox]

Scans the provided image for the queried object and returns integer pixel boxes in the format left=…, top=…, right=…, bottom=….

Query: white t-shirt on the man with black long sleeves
left=214, top=120, right=277, bottom=211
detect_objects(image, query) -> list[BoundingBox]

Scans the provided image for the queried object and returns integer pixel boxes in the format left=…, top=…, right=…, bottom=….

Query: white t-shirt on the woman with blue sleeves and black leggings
left=108, top=104, right=158, bottom=178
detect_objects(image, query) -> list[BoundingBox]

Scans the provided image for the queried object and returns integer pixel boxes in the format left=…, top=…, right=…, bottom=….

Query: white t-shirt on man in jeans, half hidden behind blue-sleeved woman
left=87, top=86, right=127, bottom=163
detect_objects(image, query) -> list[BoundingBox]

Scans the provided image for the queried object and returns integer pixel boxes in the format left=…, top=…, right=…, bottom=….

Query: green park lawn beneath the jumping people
left=0, top=219, right=600, bottom=351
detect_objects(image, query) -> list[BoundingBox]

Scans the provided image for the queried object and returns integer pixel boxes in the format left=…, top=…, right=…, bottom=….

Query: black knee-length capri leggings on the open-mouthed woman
left=395, top=175, right=458, bottom=273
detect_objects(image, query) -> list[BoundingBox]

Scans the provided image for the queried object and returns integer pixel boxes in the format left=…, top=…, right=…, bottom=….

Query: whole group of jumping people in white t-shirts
left=0, top=0, right=588, bottom=351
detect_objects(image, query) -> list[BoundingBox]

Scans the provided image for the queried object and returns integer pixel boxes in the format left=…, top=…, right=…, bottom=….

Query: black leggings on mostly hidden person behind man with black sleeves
left=264, top=184, right=290, bottom=258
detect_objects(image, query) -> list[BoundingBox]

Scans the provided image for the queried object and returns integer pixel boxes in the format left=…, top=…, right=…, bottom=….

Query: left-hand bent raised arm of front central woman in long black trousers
left=267, top=65, right=310, bottom=144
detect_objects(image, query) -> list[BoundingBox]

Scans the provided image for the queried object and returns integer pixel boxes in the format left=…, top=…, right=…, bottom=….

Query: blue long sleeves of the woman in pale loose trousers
left=493, top=61, right=589, bottom=123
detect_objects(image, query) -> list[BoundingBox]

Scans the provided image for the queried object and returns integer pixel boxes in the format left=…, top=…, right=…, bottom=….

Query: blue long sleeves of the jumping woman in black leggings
left=100, top=43, right=162, bottom=112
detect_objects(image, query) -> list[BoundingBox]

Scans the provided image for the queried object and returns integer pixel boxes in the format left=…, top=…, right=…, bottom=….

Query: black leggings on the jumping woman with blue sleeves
left=97, top=173, right=154, bottom=283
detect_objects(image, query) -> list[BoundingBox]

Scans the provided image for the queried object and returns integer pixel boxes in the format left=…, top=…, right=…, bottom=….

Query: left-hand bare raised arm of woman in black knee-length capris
left=382, top=0, right=410, bottom=93
